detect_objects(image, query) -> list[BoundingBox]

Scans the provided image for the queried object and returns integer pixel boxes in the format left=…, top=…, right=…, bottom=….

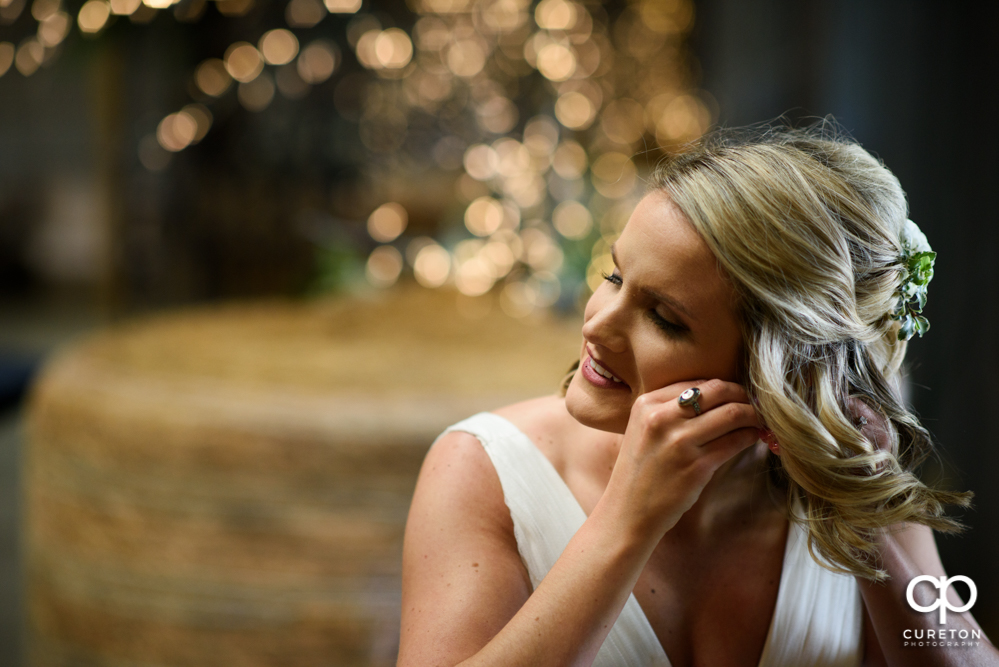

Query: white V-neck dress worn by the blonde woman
left=438, top=412, right=863, bottom=667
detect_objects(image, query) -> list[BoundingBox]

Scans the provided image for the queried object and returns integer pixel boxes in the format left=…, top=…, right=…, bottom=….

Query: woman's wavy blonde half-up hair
left=652, top=121, right=971, bottom=580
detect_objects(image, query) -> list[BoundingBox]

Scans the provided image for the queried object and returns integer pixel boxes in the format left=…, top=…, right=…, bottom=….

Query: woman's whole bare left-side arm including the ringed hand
left=399, top=381, right=758, bottom=667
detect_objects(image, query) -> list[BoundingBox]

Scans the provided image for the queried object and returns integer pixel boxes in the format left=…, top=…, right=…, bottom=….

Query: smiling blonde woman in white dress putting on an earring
left=399, top=129, right=999, bottom=667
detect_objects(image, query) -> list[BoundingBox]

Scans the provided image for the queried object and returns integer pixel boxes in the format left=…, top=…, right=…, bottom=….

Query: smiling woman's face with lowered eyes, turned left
left=566, top=193, right=741, bottom=433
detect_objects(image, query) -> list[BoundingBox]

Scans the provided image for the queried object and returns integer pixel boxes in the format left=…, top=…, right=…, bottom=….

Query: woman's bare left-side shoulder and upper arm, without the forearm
left=398, top=431, right=531, bottom=665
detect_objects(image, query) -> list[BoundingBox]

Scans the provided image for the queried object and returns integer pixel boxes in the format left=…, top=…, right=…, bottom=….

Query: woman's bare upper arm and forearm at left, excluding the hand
left=399, top=433, right=655, bottom=666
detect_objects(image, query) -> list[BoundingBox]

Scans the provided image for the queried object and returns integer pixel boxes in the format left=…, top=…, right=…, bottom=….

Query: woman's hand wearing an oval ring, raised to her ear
left=606, top=380, right=762, bottom=540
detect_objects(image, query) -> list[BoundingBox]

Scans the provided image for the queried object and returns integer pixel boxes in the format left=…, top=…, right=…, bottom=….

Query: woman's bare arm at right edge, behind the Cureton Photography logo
left=858, top=524, right=999, bottom=667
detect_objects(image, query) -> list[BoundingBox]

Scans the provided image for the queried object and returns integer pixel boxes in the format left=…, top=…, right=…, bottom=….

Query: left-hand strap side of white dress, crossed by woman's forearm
left=441, top=412, right=670, bottom=667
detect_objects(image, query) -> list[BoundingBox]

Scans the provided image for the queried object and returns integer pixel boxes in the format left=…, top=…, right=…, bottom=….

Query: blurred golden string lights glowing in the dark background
left=9, top=0, right=712, bottom=317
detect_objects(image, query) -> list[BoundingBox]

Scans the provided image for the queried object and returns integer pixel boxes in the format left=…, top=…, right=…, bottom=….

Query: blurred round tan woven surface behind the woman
left=25, top=290, right=580, bottom=666
